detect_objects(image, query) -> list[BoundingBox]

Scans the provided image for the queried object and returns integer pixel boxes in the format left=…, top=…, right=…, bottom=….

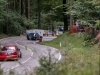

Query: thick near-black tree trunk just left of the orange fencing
left=63, top=0, right=68, bottom=32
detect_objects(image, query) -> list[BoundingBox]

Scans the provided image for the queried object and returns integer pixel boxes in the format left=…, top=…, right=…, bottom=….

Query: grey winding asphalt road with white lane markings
left=0, top=36, right=61, bottom=75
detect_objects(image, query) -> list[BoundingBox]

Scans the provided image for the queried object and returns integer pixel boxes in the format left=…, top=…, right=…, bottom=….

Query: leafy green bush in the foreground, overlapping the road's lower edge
left=35, top=49, right=58, bottom=75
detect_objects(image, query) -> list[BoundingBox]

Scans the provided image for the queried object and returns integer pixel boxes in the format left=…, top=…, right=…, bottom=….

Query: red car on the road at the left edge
left=0, top=45, right=22, bottom=61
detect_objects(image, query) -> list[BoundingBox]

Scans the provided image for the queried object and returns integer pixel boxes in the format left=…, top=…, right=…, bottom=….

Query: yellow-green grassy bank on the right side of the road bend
left=41, top=33, right=100, bottom=75
